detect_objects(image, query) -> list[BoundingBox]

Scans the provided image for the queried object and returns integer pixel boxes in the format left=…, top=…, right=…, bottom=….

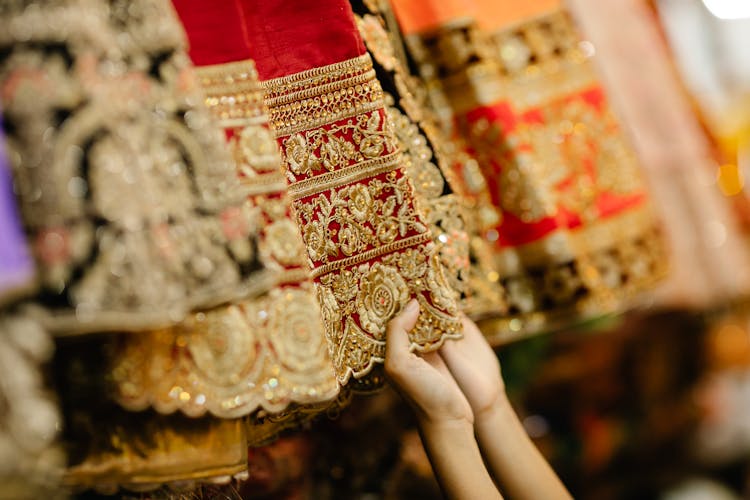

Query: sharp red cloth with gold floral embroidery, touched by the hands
left=241, top=0, right=461, bottom=389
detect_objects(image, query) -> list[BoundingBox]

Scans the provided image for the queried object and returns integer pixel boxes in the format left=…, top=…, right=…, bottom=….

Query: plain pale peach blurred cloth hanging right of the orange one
left=568, top=0, right=750, bottom=307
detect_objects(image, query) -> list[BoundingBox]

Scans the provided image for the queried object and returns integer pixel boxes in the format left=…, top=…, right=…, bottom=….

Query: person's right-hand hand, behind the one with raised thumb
left=440, top=316, right=505, bottom=421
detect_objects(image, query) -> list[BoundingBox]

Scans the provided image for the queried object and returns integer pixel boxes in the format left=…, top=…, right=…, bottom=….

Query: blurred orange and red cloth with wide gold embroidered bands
left=394, top=0, right=667, bottom=341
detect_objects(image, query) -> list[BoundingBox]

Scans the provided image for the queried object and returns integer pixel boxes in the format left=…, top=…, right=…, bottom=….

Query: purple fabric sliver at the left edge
left=0, top=116, right=34, bottom=299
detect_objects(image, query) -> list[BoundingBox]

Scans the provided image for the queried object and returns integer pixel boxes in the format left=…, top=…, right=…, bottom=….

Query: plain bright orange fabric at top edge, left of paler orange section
left=391, top=0, right=476, bottom=35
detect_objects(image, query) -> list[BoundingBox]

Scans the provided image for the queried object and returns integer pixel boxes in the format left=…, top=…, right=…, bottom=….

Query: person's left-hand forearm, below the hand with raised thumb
left=419, top=421, right=502, bottom=500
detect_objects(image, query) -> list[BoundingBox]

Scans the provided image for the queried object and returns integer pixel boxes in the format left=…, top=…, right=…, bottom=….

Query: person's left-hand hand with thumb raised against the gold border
left=385, top=300, right=474, bottom=425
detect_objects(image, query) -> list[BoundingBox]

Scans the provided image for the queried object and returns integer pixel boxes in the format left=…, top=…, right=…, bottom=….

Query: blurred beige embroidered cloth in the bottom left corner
left=0, top=314, right=65, bottom=500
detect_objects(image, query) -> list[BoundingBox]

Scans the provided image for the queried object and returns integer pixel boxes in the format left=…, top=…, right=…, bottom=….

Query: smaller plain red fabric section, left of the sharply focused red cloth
left=172, top=0, right=250, bottom=66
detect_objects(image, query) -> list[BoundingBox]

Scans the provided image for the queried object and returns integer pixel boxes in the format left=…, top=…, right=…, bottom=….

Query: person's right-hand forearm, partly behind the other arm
left=474, top=396, right=571, bottom=500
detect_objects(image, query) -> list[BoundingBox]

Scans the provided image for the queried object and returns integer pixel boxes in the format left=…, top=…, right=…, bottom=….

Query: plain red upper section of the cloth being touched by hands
left=238, top=0, right=365, bottom=80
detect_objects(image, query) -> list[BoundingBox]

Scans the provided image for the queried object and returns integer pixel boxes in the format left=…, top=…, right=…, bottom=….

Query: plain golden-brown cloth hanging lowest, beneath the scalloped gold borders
left=63, top=412, right=247, bottom=494
